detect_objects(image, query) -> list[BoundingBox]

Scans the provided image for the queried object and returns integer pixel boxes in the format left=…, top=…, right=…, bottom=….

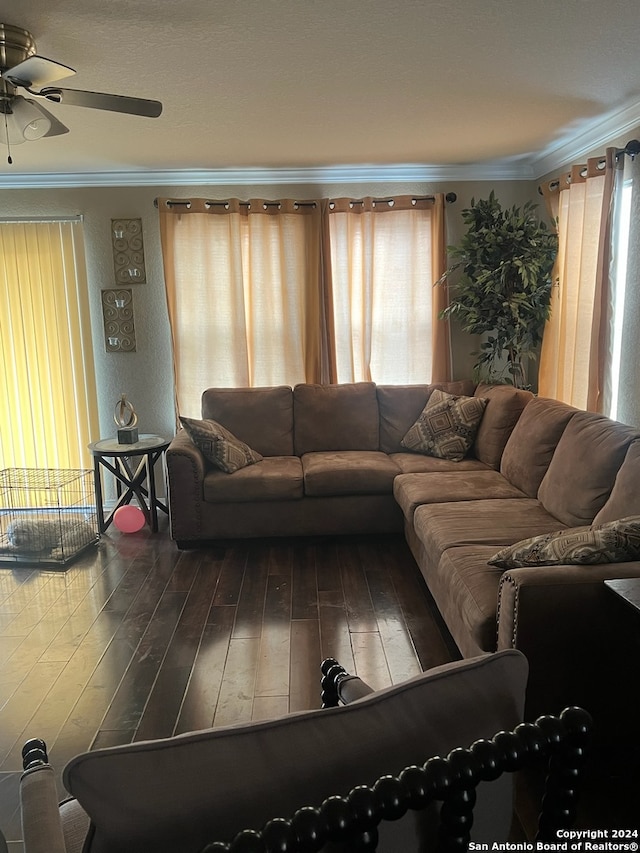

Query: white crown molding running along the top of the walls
left=0, top=100, right=640, bottom=189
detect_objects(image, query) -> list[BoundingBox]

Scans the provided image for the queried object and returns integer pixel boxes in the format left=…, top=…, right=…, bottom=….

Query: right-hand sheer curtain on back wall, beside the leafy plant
left=329, top=196, right=449, bottom=383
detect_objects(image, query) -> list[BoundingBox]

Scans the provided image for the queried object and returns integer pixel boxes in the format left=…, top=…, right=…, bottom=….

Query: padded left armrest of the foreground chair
left=20, top=764, right=66, bottom=853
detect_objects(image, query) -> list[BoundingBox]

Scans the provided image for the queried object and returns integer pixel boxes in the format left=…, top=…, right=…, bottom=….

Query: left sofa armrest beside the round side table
left=166, top=430, right=208, bottom=540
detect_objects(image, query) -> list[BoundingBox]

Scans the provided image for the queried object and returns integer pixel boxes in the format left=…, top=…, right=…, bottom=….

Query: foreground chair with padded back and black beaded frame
left=21, top=650, right=588, bottom=853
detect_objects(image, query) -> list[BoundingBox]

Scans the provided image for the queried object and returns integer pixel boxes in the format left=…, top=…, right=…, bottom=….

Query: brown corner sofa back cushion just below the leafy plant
left=472, top=385, right=533, bottom=471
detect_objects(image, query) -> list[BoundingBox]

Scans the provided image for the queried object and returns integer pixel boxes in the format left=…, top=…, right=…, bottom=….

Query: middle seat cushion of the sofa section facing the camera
left=302, top=450, right=400, bottom=497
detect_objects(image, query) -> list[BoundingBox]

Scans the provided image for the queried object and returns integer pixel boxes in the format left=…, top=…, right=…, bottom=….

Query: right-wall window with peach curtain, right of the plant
left=539, top=148, right=640, bottom=426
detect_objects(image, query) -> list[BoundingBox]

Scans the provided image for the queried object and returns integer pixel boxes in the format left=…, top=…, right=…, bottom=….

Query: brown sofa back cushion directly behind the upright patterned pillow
left=376, top=379, right=475, bottom=453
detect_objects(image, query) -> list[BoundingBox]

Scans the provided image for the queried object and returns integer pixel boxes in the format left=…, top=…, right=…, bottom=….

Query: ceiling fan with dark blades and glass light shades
left=0, top=24, right=162, bottom=163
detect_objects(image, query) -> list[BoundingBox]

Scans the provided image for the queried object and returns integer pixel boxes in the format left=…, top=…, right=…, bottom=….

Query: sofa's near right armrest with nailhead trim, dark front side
left=497, top=561, right=640, bottom=720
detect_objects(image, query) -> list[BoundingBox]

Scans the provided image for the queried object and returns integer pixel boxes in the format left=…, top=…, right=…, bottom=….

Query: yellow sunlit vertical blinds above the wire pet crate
left=0, top=220, right=98, bottom=469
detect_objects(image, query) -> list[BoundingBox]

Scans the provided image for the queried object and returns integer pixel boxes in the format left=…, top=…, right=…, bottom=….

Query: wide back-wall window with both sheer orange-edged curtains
left=158, top=196, right=450, bottom=417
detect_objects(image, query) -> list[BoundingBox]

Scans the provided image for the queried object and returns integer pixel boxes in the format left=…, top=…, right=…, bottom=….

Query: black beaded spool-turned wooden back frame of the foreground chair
left=203, top=707, right=592, bottom=853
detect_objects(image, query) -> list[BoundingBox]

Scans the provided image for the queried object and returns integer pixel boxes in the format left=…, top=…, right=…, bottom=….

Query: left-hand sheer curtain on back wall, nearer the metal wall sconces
left=158, top=199, right=322, bottom=417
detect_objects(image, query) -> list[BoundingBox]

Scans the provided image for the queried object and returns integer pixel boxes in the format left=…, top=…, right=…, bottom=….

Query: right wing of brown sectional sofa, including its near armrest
left=394, top=398, right=640, bottom=726
